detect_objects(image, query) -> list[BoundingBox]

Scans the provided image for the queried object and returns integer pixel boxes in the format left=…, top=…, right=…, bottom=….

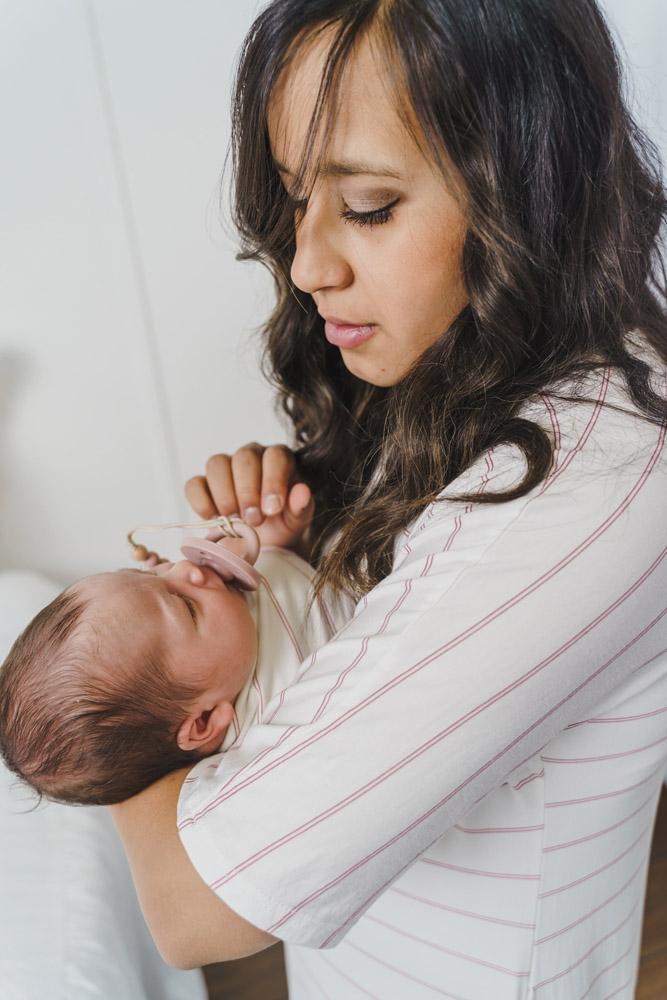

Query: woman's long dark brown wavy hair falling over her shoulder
left=224, top=0, right=667, bottom=598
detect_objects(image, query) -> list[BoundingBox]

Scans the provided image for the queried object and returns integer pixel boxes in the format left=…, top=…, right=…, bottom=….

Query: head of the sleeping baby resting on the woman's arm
left=0, top=560, right=257, bottom=805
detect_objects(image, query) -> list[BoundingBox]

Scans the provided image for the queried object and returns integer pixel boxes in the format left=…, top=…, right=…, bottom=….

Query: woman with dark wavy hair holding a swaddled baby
left=113, top=0, right=667, bottom=1000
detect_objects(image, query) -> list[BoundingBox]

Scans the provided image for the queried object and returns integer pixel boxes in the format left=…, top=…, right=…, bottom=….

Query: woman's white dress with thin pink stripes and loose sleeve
left=178, top=332, right=667, bottom=1000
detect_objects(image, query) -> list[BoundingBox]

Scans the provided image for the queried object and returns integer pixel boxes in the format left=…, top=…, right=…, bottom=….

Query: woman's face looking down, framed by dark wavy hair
left=267, top=29, right=468, bottom=386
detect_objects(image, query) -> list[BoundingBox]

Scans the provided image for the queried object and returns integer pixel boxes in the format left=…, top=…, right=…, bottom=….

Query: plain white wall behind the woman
left=0, top=0, right=667, bottom=583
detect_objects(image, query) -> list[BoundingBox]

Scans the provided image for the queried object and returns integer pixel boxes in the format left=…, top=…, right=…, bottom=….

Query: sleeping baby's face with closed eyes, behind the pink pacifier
left=76, top=559, right=257, bottom=700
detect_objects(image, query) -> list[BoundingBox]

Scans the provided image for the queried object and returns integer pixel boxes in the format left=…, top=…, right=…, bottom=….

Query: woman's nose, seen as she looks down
left=290, top=198, right=353, bottom=295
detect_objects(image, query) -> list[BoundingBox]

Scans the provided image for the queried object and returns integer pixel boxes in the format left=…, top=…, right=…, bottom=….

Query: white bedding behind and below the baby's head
left=0, top=572, right=207, bottom=1000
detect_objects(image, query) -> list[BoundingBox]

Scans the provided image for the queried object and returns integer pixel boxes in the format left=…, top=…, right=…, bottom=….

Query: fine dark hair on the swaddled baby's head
left=0, top=590, right=201, bottom=805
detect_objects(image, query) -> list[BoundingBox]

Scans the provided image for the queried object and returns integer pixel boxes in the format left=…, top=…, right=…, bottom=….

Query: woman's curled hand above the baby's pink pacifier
left=185, top=441, right=315, bottom=558
